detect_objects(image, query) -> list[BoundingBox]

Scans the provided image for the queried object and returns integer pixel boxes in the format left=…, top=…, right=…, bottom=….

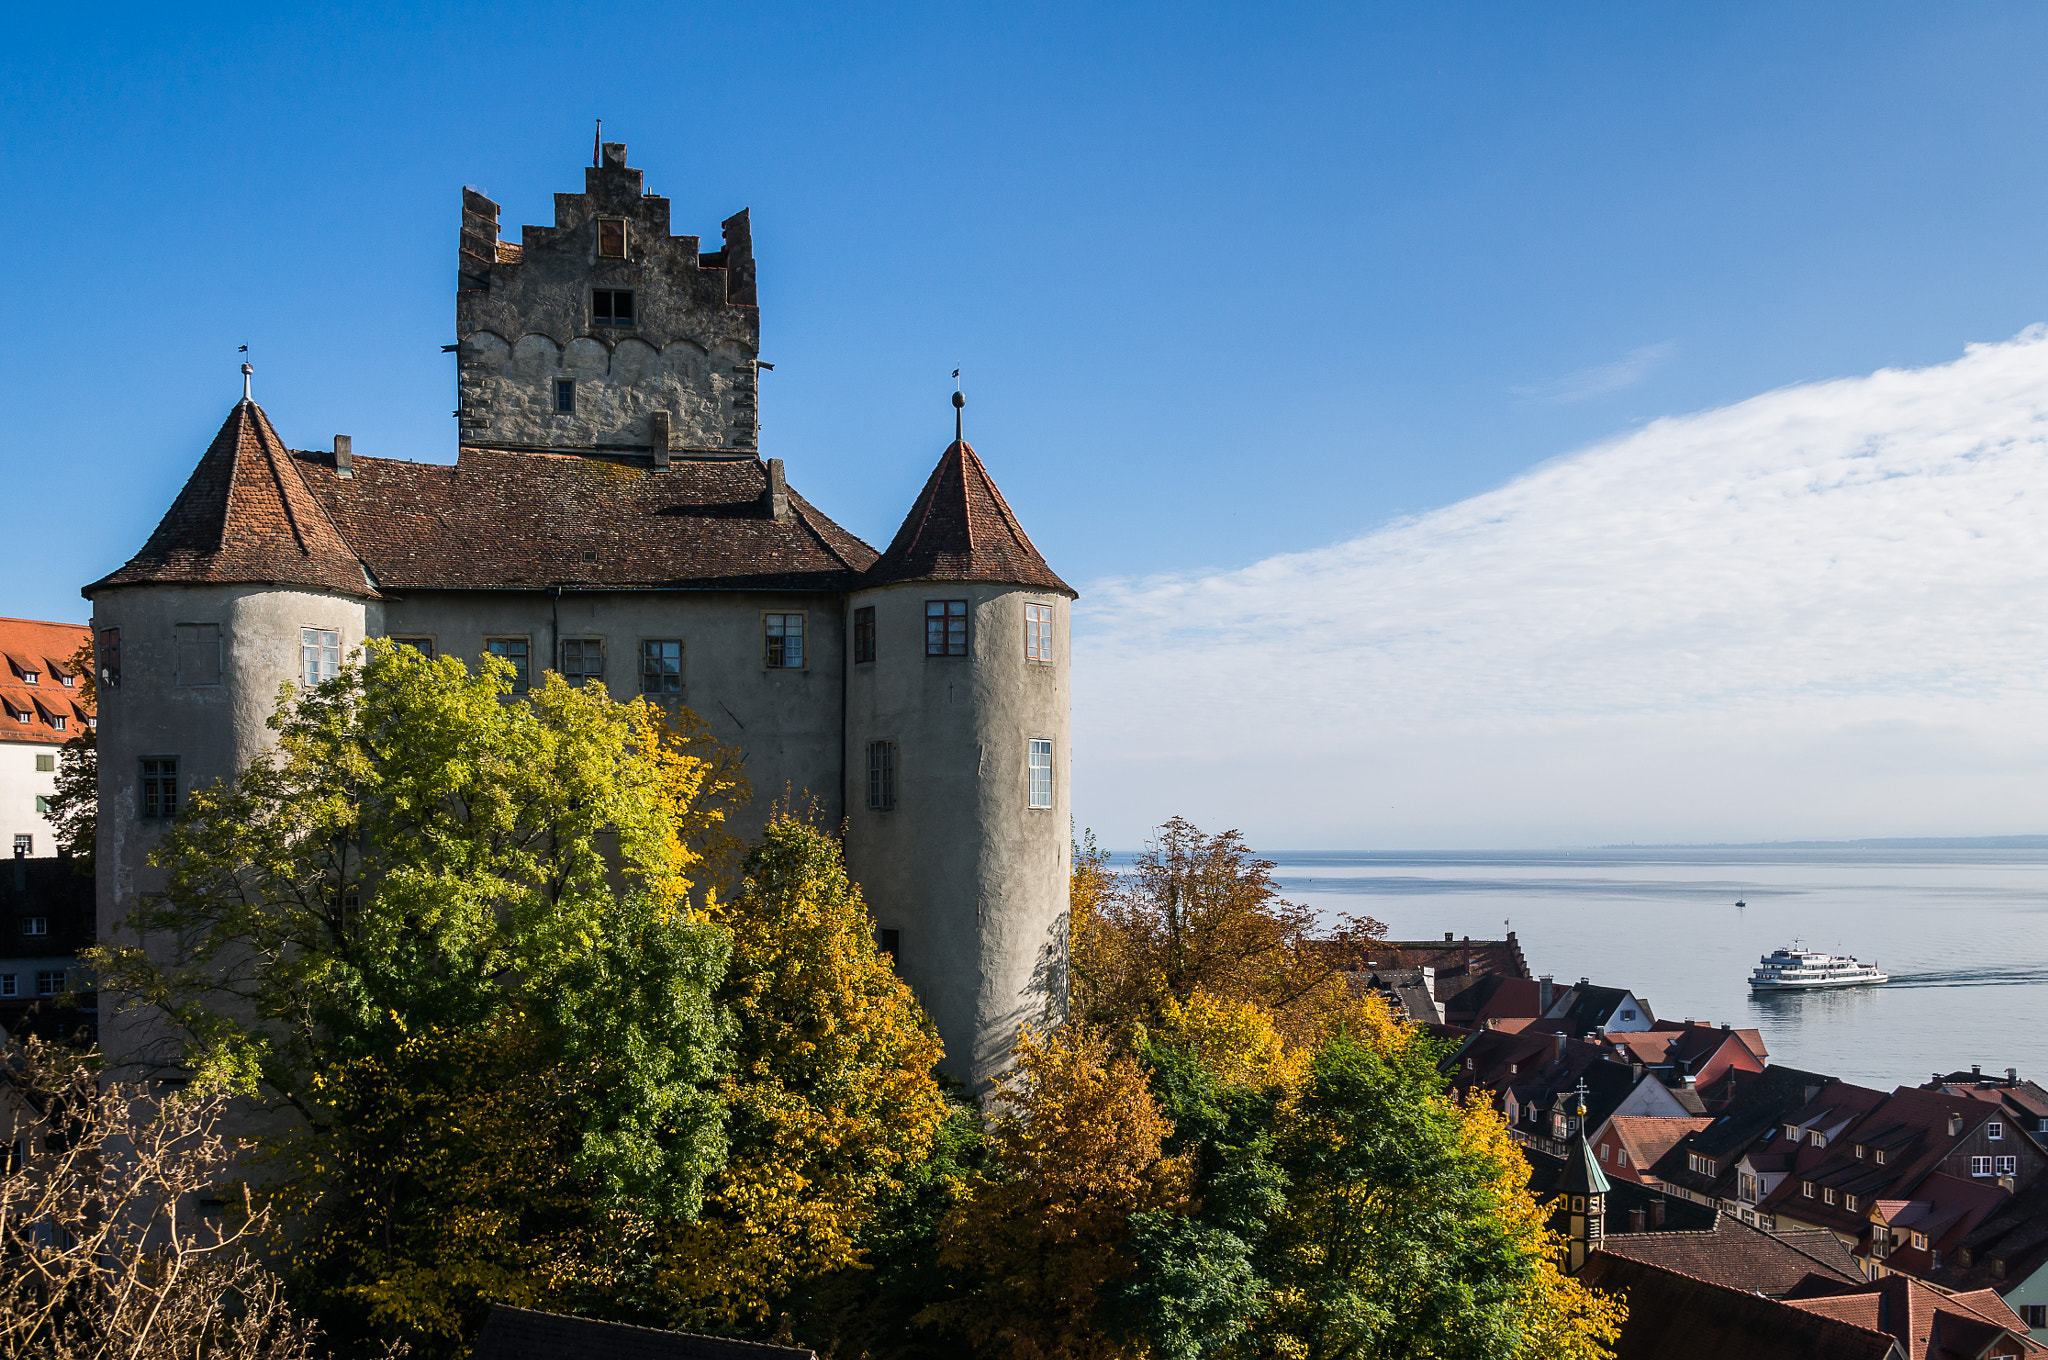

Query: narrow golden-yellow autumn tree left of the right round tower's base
left=662, top=811, right=948, bottom=1323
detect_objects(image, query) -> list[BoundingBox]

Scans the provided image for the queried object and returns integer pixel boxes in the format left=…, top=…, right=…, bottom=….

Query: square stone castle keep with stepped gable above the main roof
left=455, top=141, right=760, bottom=463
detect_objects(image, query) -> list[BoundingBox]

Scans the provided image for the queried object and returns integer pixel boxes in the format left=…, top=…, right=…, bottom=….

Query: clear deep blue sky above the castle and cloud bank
left=0, top=4, right=2048, bottom=844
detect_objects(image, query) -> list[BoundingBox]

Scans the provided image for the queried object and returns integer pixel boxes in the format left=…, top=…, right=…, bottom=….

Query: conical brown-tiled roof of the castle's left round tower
left=84, top=397, right=377, bottom=596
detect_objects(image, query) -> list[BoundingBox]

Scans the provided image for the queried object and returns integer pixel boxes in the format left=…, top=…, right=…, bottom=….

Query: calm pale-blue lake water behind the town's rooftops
left=1118, top=850, right=2048, bottom=1090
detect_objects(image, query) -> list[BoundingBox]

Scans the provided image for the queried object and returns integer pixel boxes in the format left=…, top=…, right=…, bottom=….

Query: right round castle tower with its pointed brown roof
left=846, top=438, right=1075, bottom=1092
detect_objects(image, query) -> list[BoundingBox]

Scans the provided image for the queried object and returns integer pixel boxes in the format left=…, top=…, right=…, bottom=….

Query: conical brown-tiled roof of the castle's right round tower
left=862, top=438, right=1079, bottom=596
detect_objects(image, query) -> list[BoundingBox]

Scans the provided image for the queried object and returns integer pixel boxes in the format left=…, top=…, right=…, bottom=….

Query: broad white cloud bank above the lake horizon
left=1075, top=328, right=2048, bottom=848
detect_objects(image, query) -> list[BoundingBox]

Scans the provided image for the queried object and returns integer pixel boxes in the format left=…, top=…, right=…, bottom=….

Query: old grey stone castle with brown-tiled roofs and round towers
left=84, top=143, right=1075, bottom=1088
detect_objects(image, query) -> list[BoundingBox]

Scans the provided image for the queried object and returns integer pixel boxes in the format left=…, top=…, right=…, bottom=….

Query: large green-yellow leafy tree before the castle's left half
left=94, top=641, right=745, bottom=1344
